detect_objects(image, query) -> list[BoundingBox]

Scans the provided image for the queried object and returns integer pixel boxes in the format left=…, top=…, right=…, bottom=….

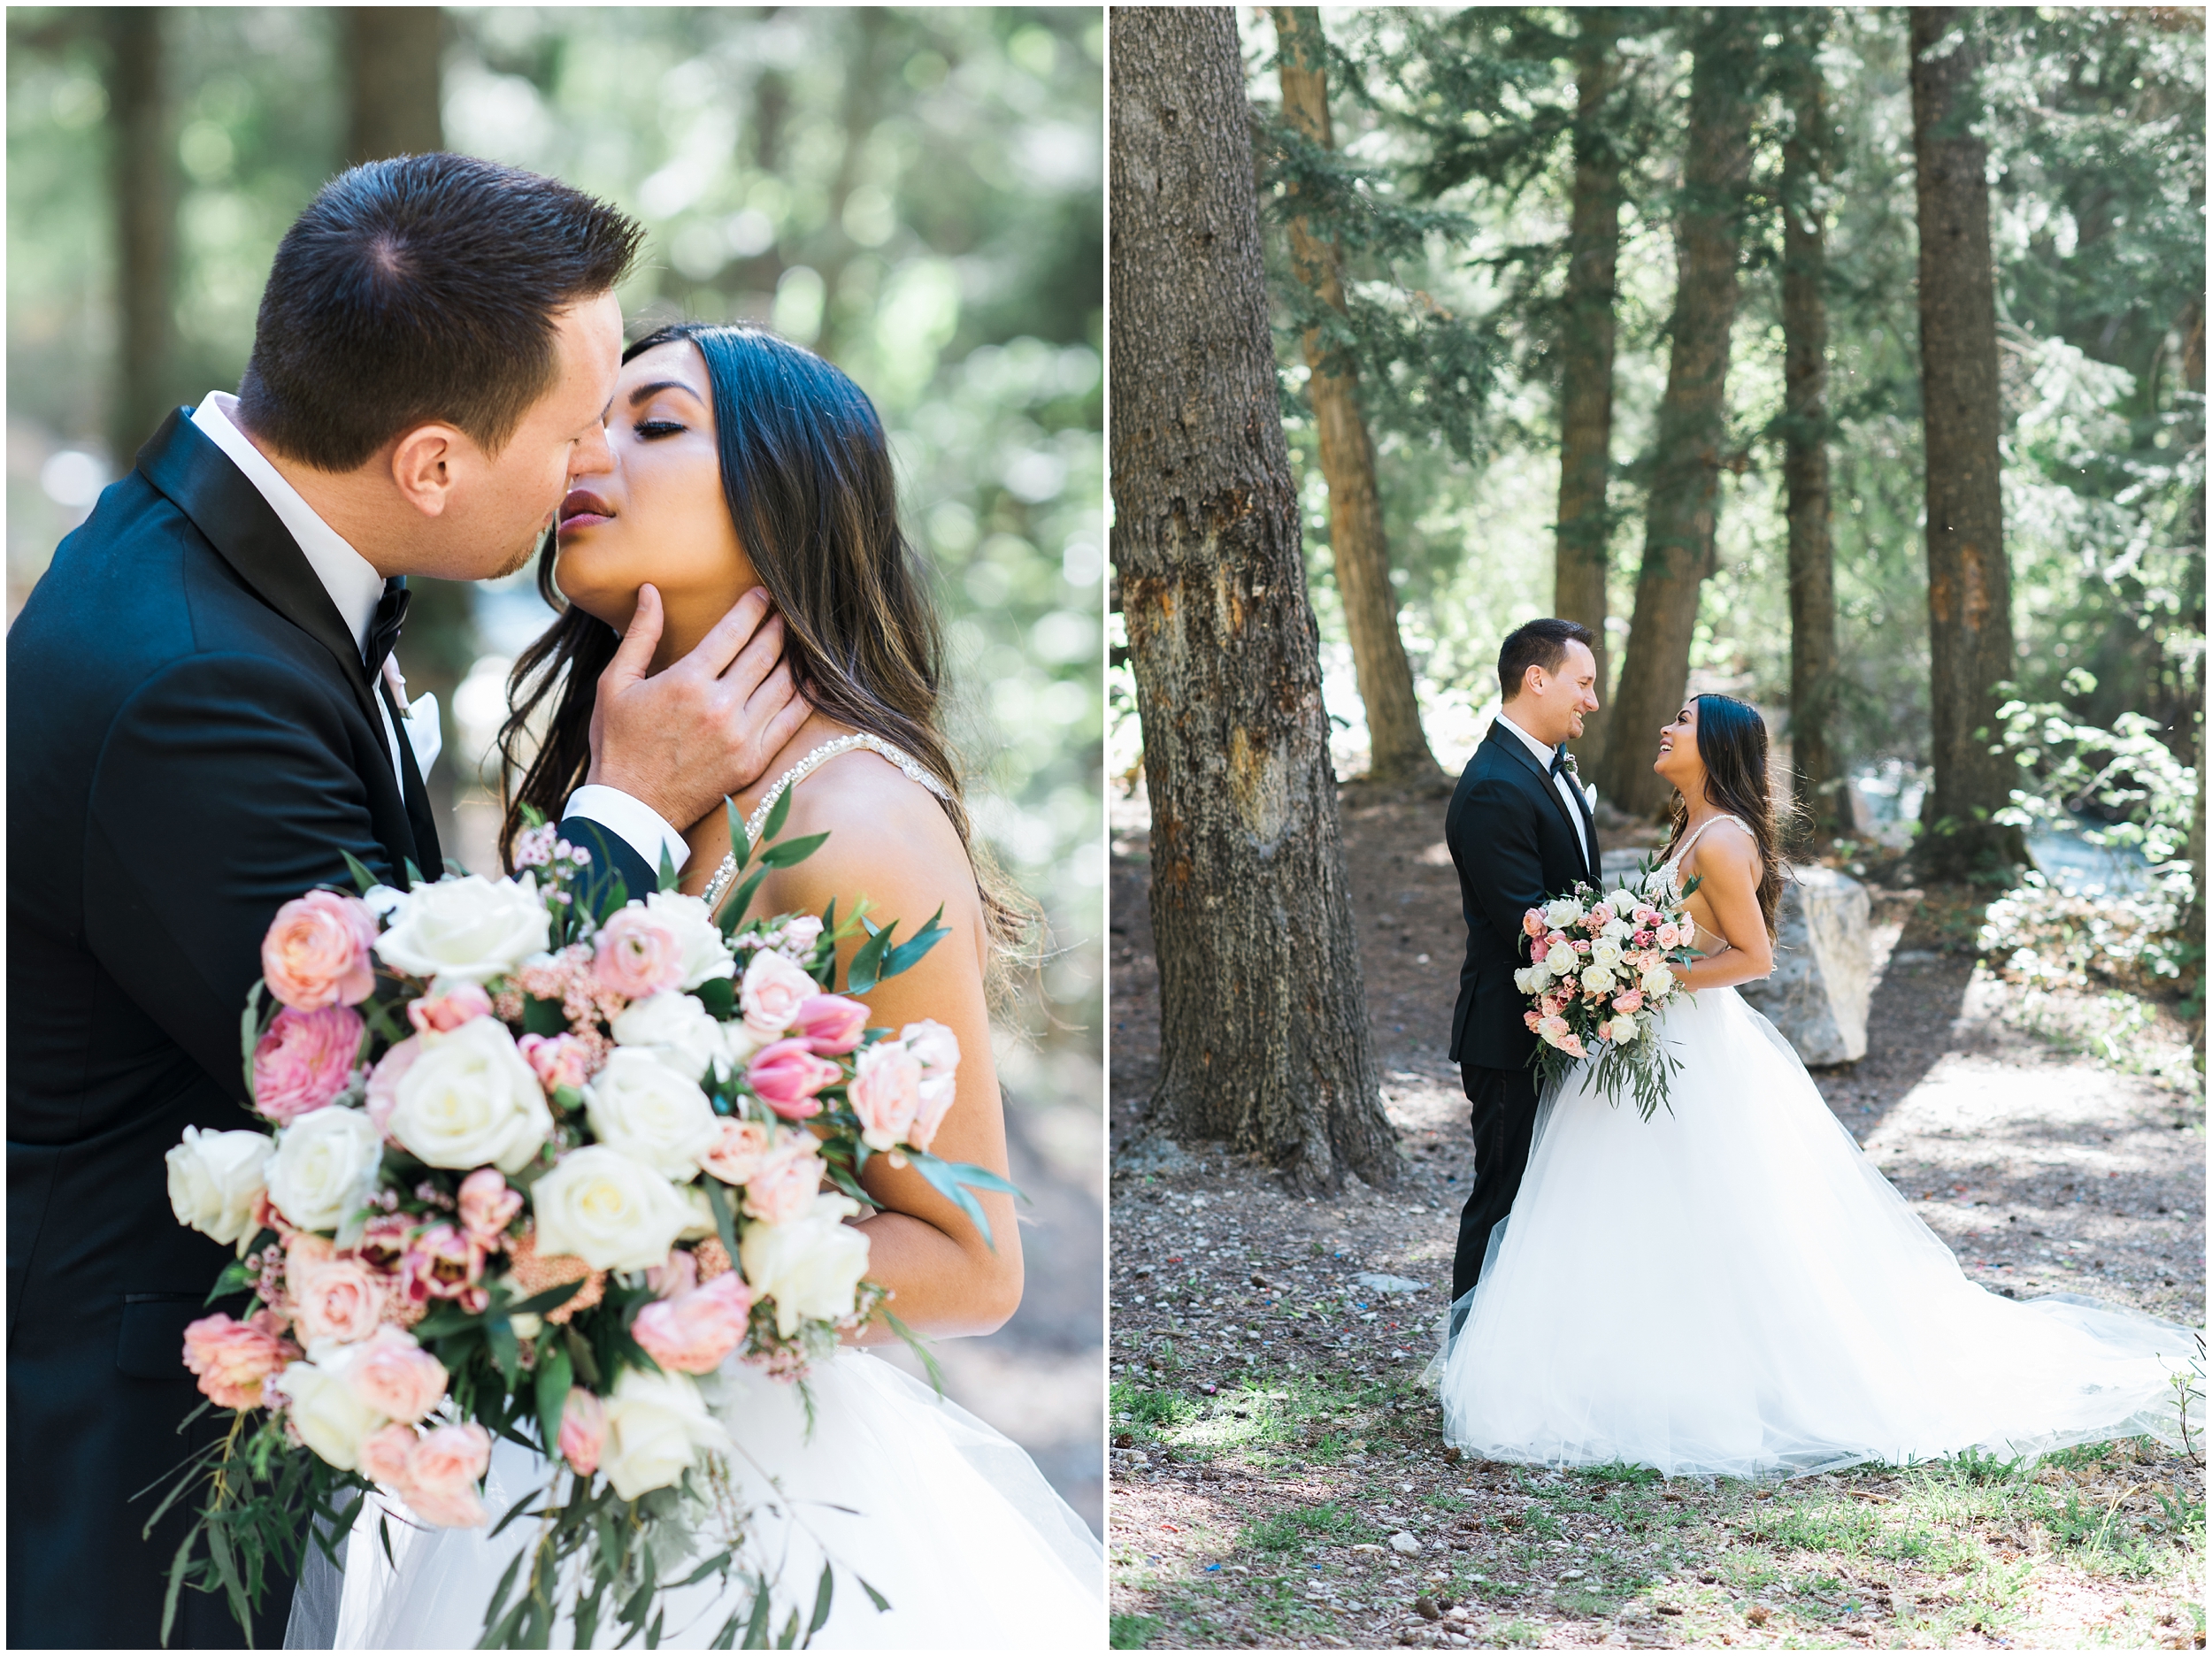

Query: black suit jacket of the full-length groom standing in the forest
left=1445, top=723, right=1600, bottom=1070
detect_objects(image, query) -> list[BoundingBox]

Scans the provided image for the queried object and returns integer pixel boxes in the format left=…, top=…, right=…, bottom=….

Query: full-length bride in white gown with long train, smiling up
left=1429, top=696, right=2197, bottom=1477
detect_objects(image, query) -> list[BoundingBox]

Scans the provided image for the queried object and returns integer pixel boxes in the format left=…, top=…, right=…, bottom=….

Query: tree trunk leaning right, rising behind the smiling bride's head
left=1600, top=11, right=1759, bottom=816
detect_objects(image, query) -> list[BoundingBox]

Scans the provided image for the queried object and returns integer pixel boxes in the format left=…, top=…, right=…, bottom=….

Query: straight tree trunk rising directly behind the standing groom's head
left=1551, top=6, right=1622, bottom=774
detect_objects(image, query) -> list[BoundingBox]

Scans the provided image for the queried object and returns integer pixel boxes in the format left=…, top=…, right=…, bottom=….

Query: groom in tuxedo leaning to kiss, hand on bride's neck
left=7, top=155, right=808, bottom=1647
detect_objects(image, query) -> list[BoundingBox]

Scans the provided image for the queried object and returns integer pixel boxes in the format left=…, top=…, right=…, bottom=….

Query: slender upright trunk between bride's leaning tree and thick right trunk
left=1783, top=26, right=1849, bottom=838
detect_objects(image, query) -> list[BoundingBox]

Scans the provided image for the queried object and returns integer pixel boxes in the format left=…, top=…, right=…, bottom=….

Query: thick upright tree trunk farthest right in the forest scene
left=1911, top=6, right=2024, bottom=878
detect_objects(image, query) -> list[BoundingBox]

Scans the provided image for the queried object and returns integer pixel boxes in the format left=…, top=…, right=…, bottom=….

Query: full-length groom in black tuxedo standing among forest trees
left=1445, top=619, right=1600, bottom=1300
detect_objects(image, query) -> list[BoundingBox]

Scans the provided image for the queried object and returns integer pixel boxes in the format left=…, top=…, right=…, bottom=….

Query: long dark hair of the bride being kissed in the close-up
left=500, top=323, right=1035, bottom=948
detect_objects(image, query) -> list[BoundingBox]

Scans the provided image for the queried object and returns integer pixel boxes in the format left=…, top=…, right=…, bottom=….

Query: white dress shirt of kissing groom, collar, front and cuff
left=193, top=391, right=690, bottom=869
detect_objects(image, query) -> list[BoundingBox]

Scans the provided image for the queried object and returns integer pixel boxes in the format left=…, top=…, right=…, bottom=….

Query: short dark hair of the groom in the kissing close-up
left=239, top=155, right=644, bottom=471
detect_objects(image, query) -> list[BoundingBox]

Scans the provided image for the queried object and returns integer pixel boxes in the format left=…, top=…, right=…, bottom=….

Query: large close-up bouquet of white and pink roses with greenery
left=149, top=796, right=1013, bottom=1645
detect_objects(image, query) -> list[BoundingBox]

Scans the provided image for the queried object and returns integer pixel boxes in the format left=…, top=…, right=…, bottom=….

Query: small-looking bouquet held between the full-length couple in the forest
left=1513, top=860, right=1699, bottom=1121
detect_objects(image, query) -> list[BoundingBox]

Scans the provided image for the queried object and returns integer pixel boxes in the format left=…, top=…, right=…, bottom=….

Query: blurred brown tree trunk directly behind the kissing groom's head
left=339, top=6, right=478, bottom=849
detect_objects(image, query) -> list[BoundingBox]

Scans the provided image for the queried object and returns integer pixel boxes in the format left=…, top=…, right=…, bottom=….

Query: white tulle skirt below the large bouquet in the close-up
left=286, top=1351, right=1106, bottom=1650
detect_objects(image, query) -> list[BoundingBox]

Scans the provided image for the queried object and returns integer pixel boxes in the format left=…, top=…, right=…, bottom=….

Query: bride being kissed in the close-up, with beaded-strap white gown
left=288, top=327, right=1106, bottom=1650
